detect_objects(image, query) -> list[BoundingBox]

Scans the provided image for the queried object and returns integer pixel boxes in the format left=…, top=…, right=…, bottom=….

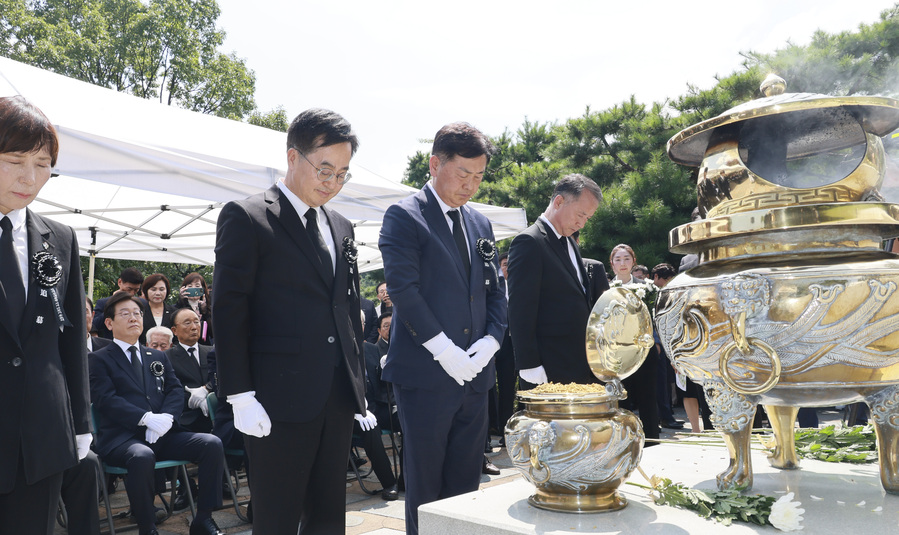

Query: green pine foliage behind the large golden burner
left=406, top=4, right=899, bottom=268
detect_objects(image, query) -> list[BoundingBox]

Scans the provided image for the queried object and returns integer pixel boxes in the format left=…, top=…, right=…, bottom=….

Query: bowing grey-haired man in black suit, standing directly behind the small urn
left=509, top=174, right=602, bottom=384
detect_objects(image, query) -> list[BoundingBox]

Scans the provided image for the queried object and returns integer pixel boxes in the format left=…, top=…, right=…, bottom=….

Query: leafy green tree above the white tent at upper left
left=0, top=0, right=255, bottom=120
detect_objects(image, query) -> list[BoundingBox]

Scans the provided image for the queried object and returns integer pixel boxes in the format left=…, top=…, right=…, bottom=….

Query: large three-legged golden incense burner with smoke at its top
left=656, top=76, right=899, bottom=493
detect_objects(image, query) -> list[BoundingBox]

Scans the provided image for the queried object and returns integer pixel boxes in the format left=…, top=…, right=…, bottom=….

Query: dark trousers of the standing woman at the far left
left=0, top=452, right=63, bottom=535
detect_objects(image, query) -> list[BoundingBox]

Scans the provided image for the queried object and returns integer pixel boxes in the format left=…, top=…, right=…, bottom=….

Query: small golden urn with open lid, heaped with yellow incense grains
left=505, top=288, right=653, bottom=513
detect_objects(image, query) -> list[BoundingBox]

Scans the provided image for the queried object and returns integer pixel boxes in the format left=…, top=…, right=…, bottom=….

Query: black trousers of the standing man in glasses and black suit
left=246, top=366, right=355, bottom=535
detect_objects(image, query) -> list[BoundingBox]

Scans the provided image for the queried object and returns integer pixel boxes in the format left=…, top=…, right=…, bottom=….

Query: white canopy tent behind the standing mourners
left=0, top=57, right=527, bottom=288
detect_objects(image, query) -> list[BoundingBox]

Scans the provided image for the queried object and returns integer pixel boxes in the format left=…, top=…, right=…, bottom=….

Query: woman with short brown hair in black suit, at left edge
left=0, top=97, right=91, bottom=535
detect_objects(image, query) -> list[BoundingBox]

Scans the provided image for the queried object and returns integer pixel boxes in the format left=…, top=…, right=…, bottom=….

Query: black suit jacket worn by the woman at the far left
left=0, top=210, right=90, bottom=494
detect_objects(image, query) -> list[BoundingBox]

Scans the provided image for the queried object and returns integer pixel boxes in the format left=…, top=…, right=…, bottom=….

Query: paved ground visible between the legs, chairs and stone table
left=56, top=409, right=840, bottom=535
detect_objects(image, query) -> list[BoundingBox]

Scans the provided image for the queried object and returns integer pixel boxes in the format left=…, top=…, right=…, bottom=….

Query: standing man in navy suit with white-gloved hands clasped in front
left=379, top=123, right=506, bottom=534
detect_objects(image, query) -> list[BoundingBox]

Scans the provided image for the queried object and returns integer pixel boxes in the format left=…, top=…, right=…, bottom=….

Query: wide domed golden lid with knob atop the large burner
left=668, top=74, right=899, bottom=167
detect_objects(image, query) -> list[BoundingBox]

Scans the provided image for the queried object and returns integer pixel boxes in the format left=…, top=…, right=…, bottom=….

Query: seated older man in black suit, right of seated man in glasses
left=165, top=308, right=213, bottom=433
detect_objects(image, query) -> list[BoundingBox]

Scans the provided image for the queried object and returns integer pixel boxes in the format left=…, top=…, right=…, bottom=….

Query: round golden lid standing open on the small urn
left=586, top=287, right=655, bottom=382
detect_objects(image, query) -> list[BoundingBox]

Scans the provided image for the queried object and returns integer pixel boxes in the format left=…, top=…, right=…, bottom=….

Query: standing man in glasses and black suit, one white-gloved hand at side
left=213, top=109, right=366, bottom=535
